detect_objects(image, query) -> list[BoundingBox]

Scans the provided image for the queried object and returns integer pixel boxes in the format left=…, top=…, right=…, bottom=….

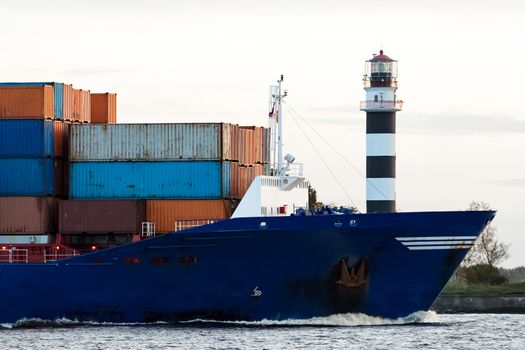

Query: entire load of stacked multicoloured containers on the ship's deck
left=0, top=82, right=269, bottom=242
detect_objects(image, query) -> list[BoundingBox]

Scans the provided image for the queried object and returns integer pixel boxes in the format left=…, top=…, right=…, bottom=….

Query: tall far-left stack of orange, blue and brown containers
left=0, top=82, right=116, bottom=243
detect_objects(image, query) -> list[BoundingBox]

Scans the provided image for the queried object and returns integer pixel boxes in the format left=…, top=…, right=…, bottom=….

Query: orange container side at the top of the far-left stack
left=0, top=86, right=55, bottom=119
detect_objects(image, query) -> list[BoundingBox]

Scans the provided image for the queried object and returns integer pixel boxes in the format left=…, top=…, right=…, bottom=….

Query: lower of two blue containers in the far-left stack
left=0, top=158, right=55, bottom=196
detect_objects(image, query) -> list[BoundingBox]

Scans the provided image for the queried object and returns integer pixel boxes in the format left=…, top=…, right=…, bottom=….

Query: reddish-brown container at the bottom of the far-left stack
left=0, top=197, right=57, bottom=234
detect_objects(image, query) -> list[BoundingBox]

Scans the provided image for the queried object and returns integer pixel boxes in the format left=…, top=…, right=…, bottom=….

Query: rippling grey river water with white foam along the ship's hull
left=0, top=312, right=525, bottom=350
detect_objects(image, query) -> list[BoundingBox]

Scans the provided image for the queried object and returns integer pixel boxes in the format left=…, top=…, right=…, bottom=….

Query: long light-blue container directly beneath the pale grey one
left=69, top=161, right=230, bottom=199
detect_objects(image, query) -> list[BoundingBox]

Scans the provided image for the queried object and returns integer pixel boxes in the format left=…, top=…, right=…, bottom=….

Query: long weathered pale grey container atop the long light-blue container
left=70, top=123, right=231, bottom=161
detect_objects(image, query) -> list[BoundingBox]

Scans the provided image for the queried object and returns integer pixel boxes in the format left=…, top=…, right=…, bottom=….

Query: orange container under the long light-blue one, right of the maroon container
left=146, top=199, right=232, bottom=233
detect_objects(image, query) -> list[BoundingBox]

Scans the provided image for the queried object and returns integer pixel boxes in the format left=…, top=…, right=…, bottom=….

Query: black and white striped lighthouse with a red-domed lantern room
left=361, top=50, right=403, bottom=213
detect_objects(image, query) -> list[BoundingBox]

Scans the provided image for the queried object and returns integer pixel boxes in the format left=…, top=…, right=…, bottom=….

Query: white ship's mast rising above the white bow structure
left=268, top=74, right=287, bottom=175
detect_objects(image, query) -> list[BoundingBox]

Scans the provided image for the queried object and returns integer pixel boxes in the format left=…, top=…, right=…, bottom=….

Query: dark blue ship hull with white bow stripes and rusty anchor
left=0, top=211, right=495, bottom=322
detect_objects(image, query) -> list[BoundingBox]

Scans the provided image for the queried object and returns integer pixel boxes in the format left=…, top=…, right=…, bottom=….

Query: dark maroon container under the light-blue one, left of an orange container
left=58, top=200, right=146, bottom=234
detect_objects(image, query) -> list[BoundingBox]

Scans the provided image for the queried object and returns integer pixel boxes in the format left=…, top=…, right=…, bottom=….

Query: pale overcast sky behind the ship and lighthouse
left=0, top=0, right=525, bottom=267
